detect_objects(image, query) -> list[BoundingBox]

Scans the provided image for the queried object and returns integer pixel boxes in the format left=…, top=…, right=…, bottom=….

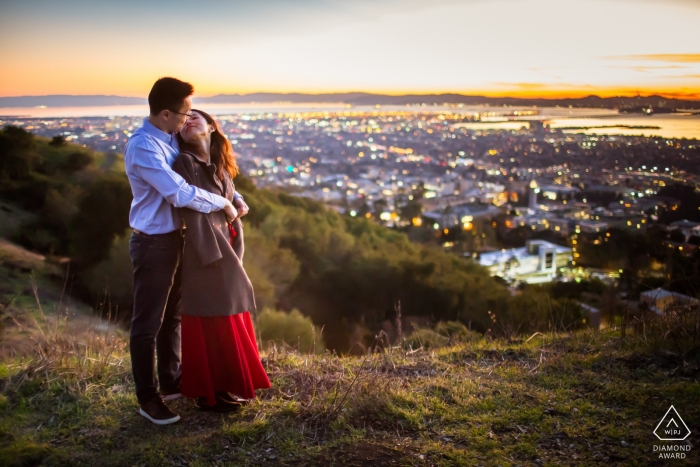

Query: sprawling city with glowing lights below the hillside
left=5, top=108, right=700, bottom=292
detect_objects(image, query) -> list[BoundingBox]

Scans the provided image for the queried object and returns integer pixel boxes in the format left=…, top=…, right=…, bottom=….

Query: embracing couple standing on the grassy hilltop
left=124, top=78, right=270, bottom=425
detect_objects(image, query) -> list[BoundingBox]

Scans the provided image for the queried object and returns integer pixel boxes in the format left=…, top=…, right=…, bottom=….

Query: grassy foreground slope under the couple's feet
left=0, top=322, right=700, bottom=467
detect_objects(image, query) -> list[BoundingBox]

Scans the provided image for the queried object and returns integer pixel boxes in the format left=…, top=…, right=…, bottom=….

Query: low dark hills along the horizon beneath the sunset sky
left=0, top=92, right=700, bottom=109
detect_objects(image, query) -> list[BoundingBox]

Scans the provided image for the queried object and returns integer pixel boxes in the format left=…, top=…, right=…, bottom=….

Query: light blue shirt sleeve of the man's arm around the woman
left=133, top=147, right=226, bottom=213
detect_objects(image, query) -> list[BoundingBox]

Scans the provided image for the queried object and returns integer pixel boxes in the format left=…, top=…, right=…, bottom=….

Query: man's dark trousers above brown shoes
left=129, top=230, right=182, bottom=404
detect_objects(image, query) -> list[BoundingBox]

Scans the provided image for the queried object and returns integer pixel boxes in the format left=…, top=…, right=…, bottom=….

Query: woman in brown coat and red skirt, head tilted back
left=173, top=110, right=270, bottom=412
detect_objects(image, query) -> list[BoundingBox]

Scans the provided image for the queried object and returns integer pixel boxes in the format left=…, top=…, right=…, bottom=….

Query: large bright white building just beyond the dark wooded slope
left=478, top=240, right=572, bottom=284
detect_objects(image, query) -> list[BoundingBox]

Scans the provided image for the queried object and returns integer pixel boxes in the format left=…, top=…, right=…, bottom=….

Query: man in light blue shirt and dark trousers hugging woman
left=124, top=78, right=248, bottom=425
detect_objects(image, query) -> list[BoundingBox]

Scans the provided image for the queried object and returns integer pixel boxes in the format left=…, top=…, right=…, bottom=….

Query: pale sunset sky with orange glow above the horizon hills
left=0, top=0, right=700, bottom=99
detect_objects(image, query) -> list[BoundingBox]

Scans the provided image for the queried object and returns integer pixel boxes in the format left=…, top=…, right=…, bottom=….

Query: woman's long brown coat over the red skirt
left=173, top=152, right=255, bottom=316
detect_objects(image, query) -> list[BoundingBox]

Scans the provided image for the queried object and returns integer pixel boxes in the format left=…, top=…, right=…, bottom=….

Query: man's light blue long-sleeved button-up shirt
left=124, top=119, right=226, bottom=235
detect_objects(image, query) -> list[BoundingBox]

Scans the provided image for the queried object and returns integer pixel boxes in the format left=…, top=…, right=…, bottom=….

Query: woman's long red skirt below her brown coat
left=181, top=311, right=270, bottom=405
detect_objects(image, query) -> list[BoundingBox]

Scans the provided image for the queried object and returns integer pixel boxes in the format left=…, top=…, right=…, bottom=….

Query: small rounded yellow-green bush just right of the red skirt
left=258, top=308, right=325, bottom=353
